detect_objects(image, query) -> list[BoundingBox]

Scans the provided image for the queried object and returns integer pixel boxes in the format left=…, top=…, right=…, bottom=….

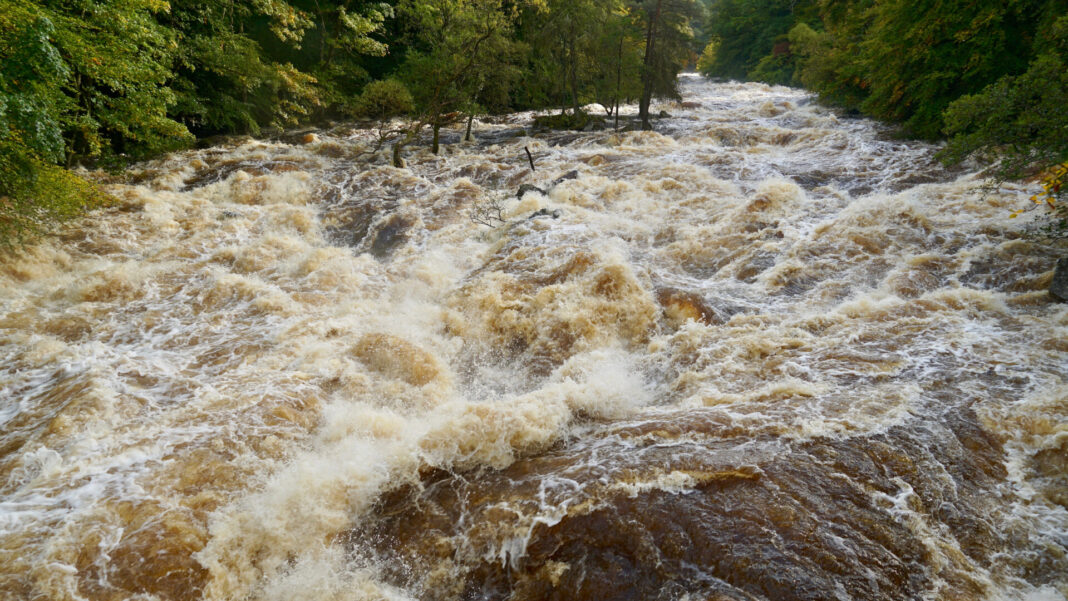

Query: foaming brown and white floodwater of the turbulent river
left=0, top=77, right=1068, bottom=601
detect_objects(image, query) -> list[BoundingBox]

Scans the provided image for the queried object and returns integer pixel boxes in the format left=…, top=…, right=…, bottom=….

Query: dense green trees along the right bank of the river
left=698, top=0, right=1068, bottom=233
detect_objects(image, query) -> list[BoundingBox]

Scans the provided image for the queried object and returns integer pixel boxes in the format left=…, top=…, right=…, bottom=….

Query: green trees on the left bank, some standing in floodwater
left=0, top=0, right=702, bottom=246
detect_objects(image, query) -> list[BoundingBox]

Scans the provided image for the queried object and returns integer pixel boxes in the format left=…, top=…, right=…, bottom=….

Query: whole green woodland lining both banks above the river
left=0, top=0, right=1068, bottom=244
